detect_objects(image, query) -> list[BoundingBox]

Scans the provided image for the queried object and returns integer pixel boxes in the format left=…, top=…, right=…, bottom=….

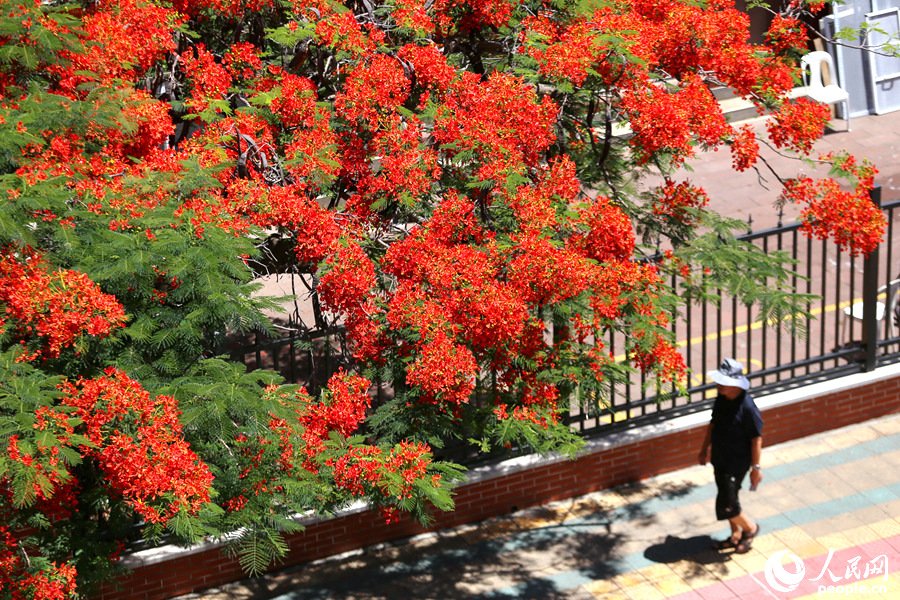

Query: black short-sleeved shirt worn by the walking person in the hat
left=711, top=392, right=763, bottom=474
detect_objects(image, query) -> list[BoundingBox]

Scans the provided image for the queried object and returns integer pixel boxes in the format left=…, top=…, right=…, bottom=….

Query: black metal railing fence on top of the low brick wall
left=232, top=188, right=900, bottom=448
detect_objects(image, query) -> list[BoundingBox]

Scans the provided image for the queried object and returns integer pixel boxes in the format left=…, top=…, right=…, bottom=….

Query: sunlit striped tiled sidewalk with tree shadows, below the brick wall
left=192, top=415, right=900, bottom=600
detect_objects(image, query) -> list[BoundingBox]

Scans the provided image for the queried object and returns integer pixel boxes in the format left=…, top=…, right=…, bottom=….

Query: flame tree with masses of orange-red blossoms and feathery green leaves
left=0, top=0, right=883, bottom=599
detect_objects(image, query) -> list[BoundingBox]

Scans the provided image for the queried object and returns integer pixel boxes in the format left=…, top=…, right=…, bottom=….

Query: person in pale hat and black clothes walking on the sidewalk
left=699, top=358, right=763, bottom=554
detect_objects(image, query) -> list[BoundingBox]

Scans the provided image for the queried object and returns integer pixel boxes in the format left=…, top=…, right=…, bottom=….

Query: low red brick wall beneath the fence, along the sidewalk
left=100, top=377, right=900, bottom=600
